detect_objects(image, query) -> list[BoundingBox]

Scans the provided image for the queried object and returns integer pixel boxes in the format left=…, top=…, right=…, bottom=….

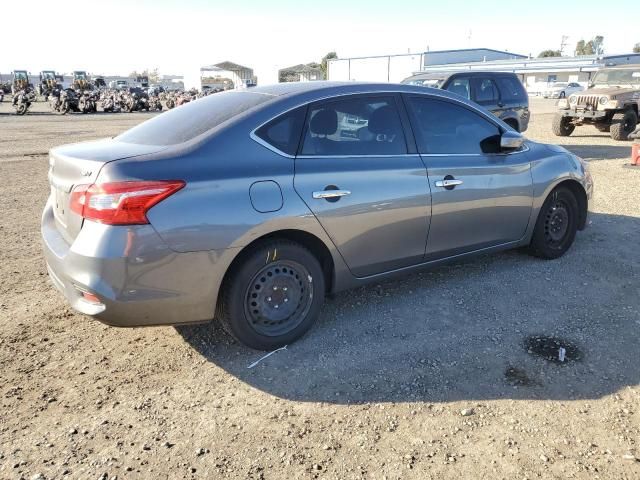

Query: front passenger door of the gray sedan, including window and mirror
left=405, top=95, right=533, bottom=260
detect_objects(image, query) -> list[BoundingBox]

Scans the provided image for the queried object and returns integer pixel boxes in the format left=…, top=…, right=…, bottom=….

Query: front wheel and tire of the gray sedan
left=529, top=187, right=579, bottom=260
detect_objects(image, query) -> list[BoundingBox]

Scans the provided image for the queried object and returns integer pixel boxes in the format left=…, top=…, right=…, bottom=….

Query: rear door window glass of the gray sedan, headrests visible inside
left=302, top=96, right=407, bottom=156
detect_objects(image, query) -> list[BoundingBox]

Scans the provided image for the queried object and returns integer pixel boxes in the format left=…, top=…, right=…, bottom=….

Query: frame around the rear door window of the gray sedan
left=295, top=92, right=412, bottom=158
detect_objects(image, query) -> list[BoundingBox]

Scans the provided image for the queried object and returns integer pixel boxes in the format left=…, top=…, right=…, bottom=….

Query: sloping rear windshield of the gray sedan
left=115, top=92, right=273, bottom=145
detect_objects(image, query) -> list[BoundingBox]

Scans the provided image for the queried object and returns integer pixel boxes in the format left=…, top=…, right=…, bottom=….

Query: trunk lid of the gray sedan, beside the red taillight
left=49, top=140, right=167, bottom=243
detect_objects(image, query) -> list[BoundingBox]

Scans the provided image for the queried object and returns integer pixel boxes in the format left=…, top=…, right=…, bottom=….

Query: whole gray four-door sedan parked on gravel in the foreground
left=42, top=82, right=593, bottom=349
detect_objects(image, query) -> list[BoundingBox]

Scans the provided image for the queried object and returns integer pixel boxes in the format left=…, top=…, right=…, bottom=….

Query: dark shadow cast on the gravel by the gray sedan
left=178, top=214, right=640, bottom=404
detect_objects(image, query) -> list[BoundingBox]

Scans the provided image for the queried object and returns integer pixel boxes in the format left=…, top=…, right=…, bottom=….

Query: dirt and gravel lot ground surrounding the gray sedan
left=0, top=99, right=640, bottom=480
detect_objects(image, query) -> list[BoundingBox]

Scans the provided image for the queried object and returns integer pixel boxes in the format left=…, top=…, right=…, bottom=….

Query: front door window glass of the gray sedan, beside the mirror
left=408, top=97, right=500, bottom=154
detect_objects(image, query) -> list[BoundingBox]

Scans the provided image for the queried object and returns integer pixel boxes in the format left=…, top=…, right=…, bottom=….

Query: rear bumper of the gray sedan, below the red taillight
left=41, top=199, right=229, bottom=327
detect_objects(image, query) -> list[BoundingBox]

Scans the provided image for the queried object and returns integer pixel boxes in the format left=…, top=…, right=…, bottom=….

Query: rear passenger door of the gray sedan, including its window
left=294, top=94, right=431, bottom=277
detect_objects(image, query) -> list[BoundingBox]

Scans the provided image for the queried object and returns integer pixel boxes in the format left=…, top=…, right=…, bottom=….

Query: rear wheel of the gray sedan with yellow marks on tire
left=216, top=240, right=325, bottom=350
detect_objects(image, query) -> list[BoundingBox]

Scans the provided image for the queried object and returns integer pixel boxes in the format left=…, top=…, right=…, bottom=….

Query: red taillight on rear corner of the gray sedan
left=70, top=180, right=185, bottom=225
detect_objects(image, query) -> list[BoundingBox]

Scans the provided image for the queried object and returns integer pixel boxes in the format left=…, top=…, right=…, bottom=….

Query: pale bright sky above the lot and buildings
left=6, top=0, right=640, bottom=84
